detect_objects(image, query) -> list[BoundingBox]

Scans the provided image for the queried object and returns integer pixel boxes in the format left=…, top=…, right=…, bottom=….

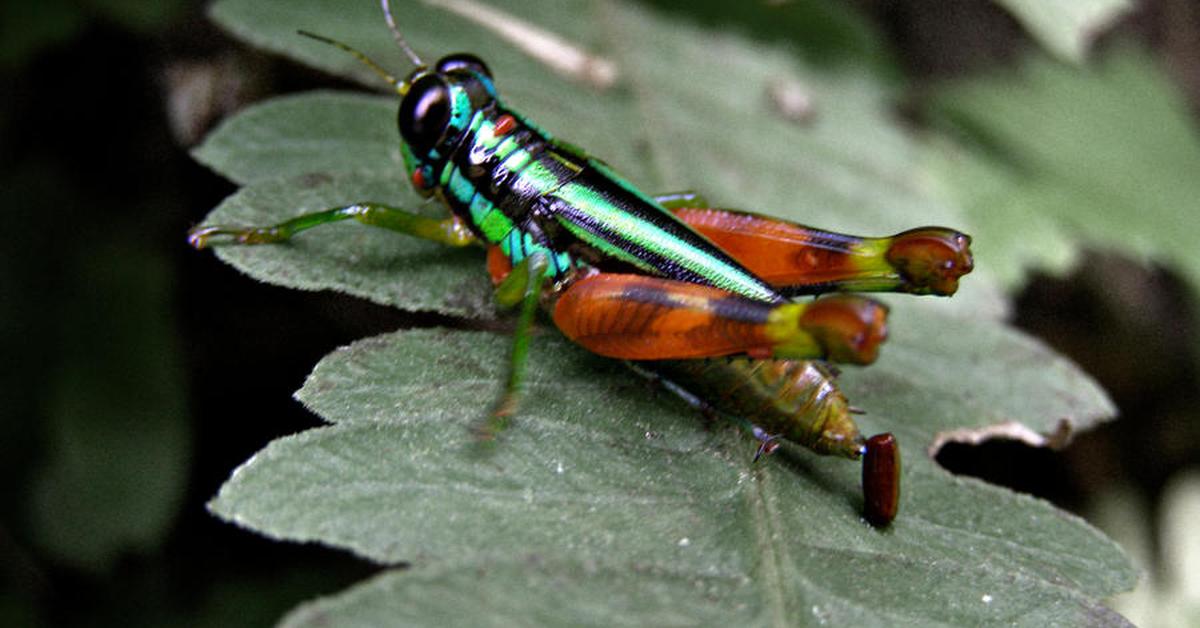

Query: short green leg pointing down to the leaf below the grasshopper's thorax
left=475, top=255, right=550, bottom=441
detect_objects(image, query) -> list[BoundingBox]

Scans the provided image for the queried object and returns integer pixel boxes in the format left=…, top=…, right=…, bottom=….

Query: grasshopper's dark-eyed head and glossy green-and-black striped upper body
left=398, top=54, right=786, bottom=303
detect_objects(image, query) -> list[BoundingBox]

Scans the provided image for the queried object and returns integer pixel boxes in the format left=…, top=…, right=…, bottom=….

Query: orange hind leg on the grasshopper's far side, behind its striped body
left=655, top=192, right=973, bottom=295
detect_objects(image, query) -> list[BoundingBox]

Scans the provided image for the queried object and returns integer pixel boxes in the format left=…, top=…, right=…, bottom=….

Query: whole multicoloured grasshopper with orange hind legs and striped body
left=188, top=0, right=972, bottom=525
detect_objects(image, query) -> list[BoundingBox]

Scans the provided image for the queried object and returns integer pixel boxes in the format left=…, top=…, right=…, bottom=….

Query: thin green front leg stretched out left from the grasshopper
left=187, top=203, right=475, bottom=249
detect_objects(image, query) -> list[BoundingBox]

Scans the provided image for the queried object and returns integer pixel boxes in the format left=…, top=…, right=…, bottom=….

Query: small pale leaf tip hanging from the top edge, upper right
left=995, top=0, right=1133, bottom=64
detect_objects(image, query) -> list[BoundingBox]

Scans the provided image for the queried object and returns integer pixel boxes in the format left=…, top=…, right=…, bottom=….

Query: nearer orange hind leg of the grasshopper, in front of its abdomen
left=553, top=273, right=887, bottom=364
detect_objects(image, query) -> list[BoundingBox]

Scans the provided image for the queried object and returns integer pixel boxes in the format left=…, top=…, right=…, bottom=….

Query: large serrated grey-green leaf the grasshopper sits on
left=198, top=0, right=1133, bottom=624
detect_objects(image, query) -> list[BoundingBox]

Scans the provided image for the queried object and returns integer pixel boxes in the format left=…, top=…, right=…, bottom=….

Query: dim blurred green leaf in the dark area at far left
left=31, top=238, right=191, bottom=572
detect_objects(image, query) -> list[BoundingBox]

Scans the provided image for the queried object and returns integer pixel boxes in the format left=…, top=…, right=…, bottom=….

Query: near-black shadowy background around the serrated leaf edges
left=0, top=0, right=1200, bottom=626
